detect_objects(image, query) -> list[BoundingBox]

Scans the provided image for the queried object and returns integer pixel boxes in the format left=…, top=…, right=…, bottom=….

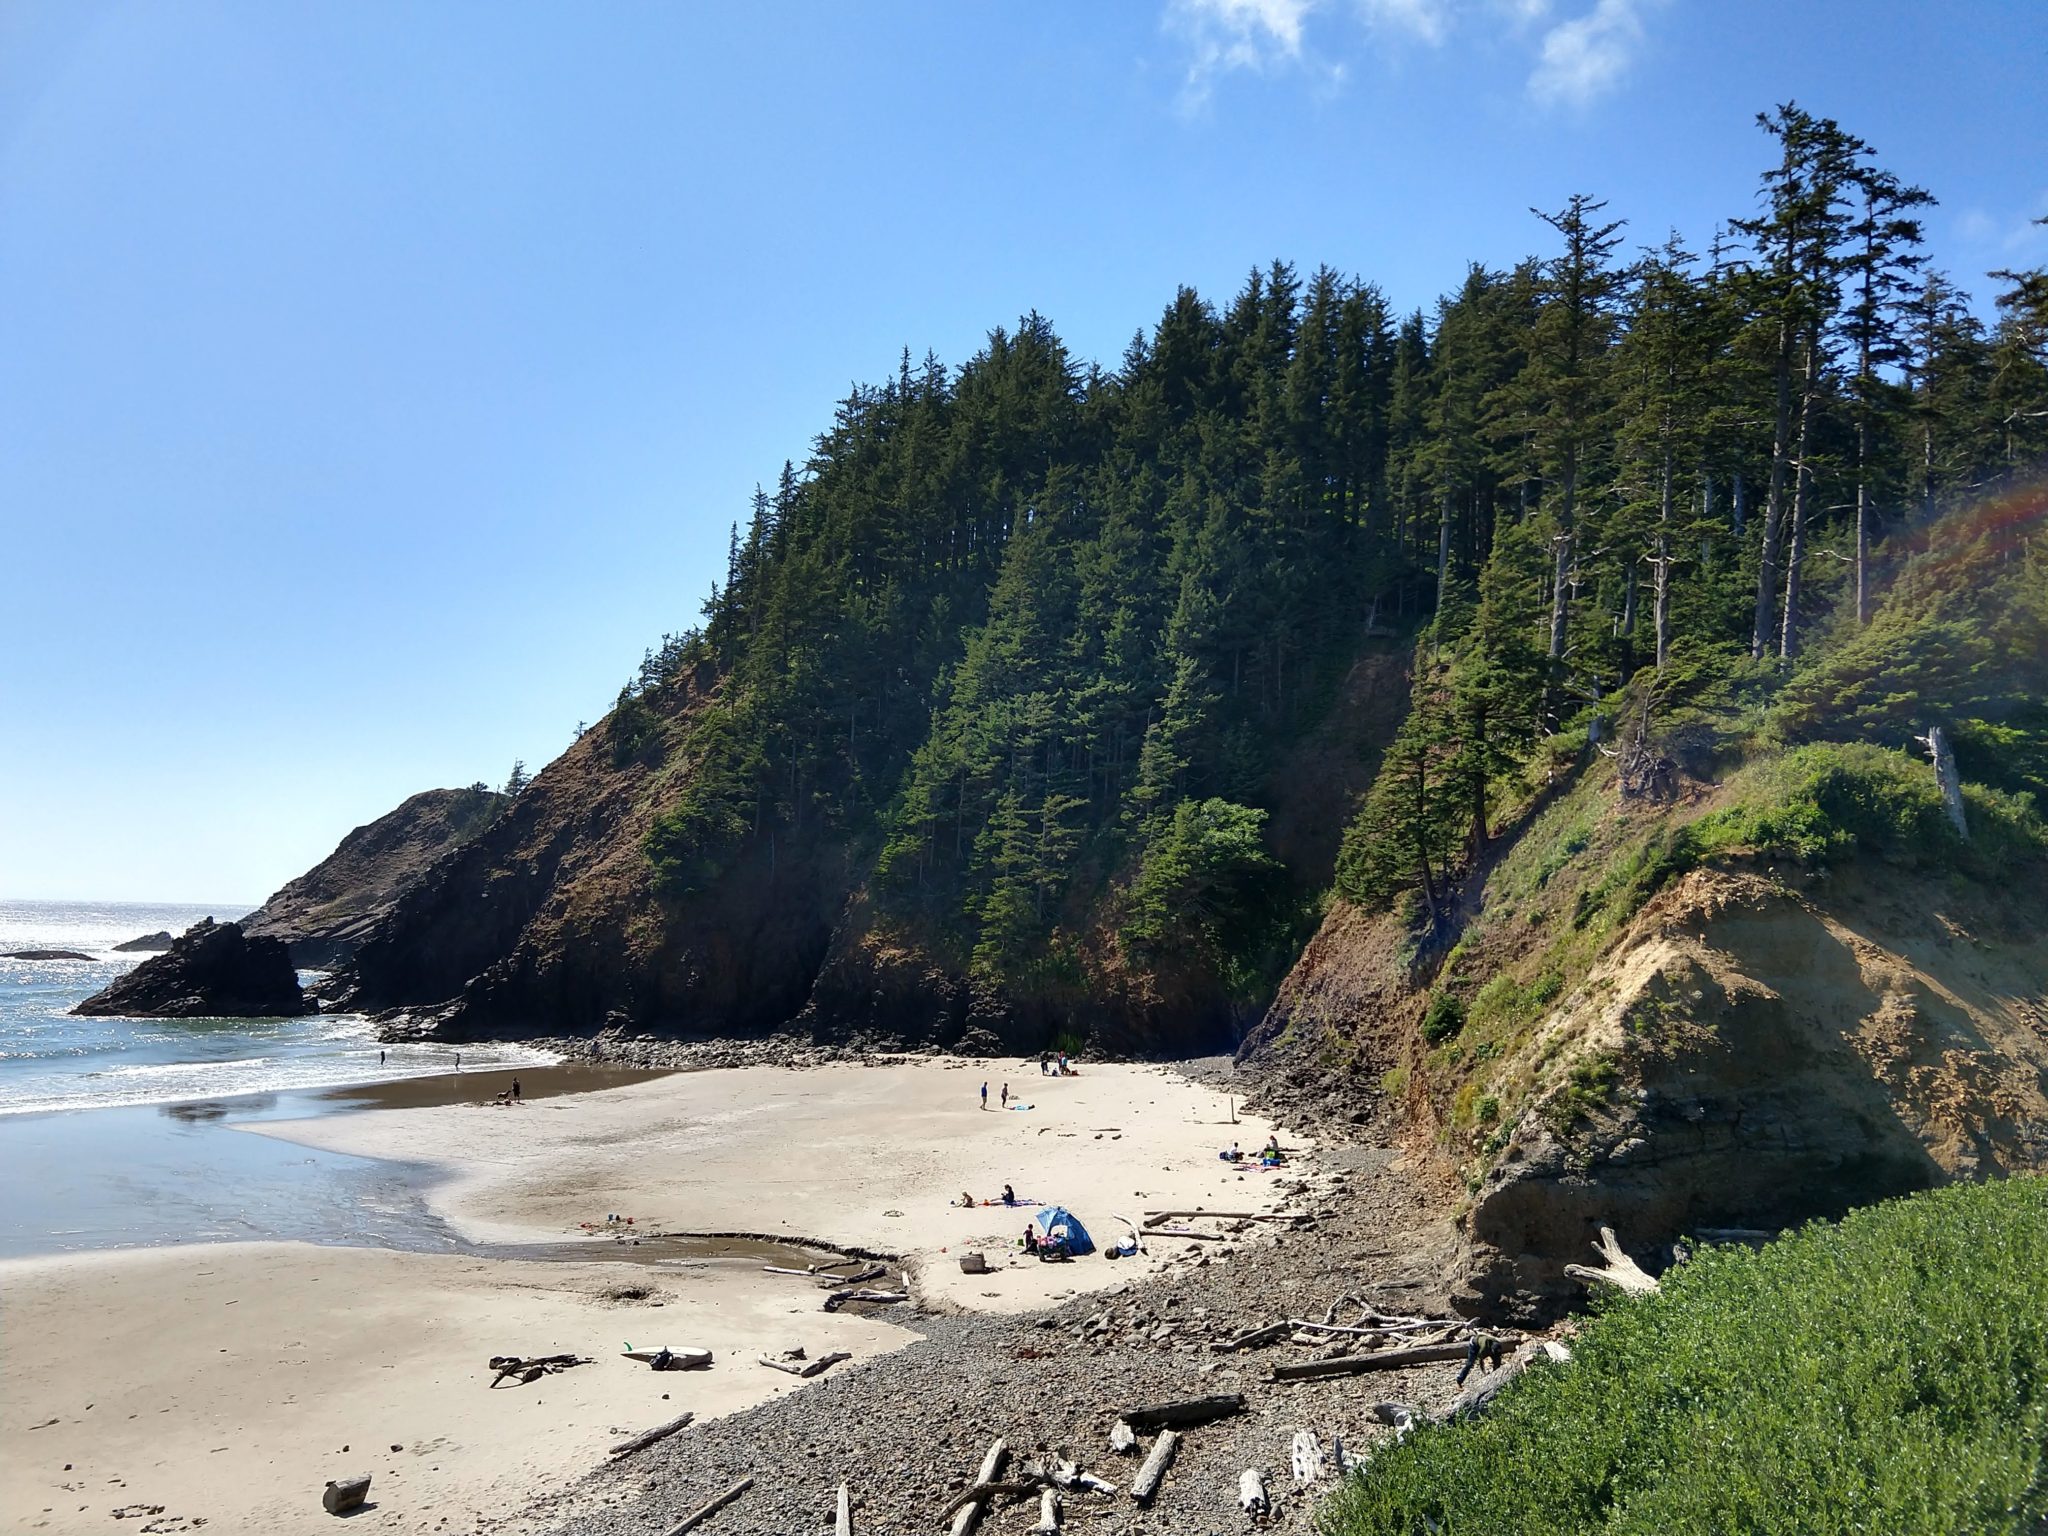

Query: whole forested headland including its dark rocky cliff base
left=344, top=106, right=2048, bottom=1049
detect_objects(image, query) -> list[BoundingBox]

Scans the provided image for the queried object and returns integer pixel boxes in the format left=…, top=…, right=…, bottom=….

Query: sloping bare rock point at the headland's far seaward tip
left=242, top=788, right=510, bottom=971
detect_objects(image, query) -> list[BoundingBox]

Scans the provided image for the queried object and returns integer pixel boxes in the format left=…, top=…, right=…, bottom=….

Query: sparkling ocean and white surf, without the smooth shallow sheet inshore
left=0, top=901, right=555, bottom=1116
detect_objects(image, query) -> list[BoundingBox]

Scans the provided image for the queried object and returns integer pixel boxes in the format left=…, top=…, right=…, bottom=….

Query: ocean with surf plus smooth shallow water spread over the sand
left=0, top=901, right=555, bottom=1257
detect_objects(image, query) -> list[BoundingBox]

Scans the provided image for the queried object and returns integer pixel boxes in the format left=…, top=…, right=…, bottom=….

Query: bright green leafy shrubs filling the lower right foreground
left=1319, top=1178, right=2048, bottom=1536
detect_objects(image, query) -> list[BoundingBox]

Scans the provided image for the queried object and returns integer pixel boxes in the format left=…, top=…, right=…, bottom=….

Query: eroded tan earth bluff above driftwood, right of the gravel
left=1249, top=847, right=2048, bottom=1315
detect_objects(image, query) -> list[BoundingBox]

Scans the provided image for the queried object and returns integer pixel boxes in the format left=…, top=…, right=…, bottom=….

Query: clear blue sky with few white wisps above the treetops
left=0, top=0, right=2048, bottom=905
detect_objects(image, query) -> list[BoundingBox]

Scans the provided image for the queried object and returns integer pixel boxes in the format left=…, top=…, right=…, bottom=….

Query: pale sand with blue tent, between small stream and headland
left=250, top=1059, right=1292, bottom=1311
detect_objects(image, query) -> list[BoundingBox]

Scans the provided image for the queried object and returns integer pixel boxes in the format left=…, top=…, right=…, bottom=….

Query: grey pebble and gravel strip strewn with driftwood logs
left=503, top=1089, right=1482, bottom=1536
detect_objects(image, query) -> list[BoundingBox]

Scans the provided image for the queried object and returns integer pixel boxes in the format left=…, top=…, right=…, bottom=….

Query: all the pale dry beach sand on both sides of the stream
left=0, top=1059, right=1298, bottom=1536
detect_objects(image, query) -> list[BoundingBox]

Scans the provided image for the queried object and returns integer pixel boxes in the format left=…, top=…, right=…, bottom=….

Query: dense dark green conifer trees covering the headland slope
left=626, top=106, right=2048, bottom=1036
